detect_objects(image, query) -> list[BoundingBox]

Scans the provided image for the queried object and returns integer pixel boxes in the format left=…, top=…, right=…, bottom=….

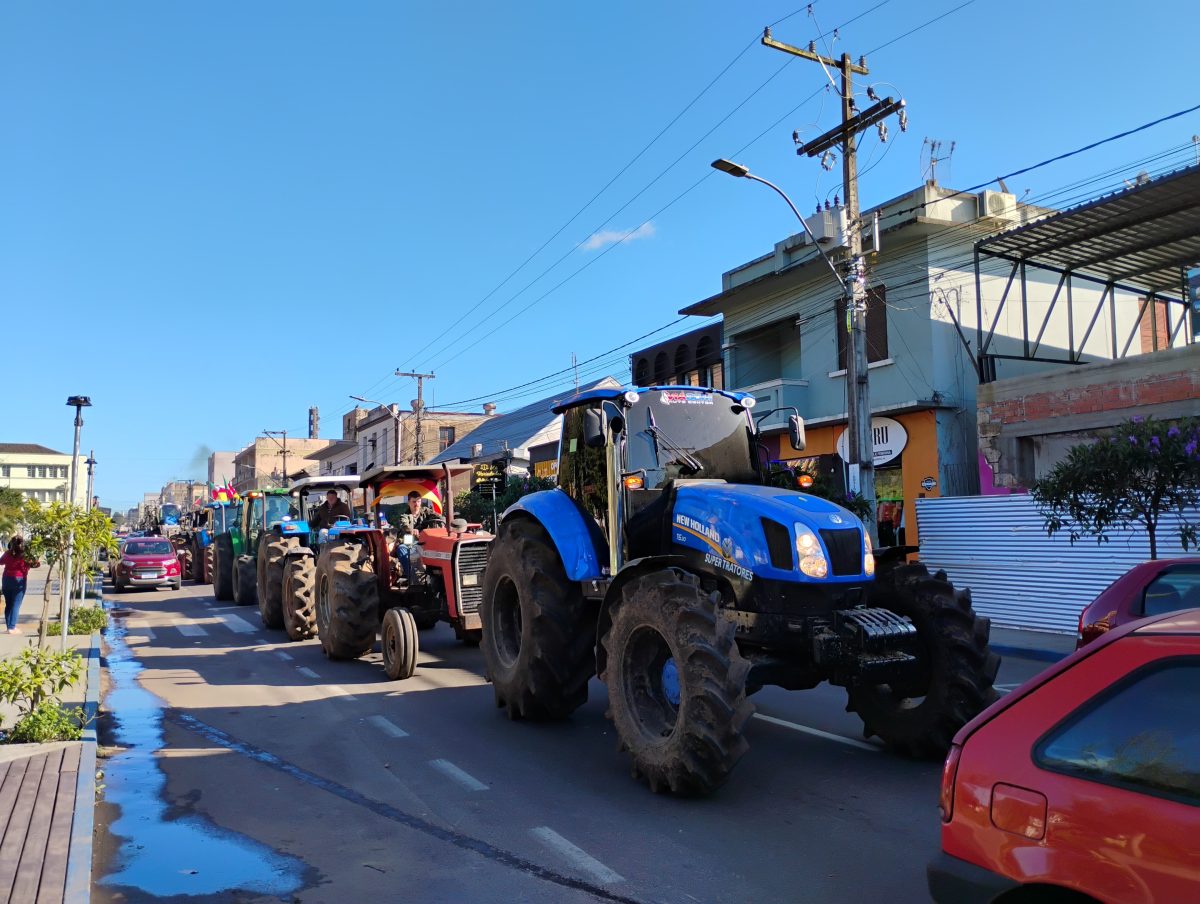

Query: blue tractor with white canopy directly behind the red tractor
left=257, top=475, right=359, bottom=640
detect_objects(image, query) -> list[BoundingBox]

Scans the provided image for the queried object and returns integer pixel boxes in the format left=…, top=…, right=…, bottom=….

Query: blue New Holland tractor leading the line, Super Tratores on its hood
left=481, top=387, right=1000, bottom=795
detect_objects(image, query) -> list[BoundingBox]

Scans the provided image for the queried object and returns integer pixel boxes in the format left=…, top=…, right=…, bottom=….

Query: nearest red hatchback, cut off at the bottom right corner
left=929, top=609, right=1200, bottom=904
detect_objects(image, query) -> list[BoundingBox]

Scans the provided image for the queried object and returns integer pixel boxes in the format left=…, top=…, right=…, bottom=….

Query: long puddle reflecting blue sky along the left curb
left=98, top=607, right=305, bottom=897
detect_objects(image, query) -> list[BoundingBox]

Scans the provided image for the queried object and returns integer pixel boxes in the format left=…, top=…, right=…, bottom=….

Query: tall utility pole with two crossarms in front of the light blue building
left=762, top=29, right=907, bottom=545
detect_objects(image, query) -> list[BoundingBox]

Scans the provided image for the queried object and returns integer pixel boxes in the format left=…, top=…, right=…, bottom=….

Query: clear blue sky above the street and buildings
left=0, top=0, right=1200, bottom=508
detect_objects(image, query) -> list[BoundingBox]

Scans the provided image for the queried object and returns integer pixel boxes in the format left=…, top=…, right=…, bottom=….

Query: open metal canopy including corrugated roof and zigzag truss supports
left=969, top=164, right=1200, bottom=383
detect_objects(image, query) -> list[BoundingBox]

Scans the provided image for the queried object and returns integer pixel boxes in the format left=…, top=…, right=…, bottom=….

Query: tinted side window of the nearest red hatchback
left=1033, top=657, right=1200, bottom=806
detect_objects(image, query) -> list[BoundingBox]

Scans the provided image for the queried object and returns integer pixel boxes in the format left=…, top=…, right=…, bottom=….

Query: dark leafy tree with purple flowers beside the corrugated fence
left=1031, top=418, right=1200, bottom=558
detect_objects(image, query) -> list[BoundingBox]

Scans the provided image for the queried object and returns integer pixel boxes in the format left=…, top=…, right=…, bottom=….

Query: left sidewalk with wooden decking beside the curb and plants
left=0, top=568, right=101, bottom=904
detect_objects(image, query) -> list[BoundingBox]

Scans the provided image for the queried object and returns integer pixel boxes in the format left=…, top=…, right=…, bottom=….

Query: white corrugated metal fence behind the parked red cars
left=917, top=496, right=1196, bottom=634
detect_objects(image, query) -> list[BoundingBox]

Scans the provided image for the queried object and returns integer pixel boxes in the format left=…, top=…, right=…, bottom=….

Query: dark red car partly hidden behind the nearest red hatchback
left=1075, top=557, right=1200, bottom=647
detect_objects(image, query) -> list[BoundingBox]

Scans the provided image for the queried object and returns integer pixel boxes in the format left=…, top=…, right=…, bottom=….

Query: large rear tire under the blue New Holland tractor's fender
left=479, top=519, right=595, bottom=719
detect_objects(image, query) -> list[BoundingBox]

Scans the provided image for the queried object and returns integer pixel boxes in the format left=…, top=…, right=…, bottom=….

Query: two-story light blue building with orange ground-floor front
left=672, top=184, right=1185, bottom=541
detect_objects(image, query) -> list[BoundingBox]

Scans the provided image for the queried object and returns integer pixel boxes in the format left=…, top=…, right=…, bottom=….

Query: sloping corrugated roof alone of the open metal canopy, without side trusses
left=976, top=160, right=1200, bottom=295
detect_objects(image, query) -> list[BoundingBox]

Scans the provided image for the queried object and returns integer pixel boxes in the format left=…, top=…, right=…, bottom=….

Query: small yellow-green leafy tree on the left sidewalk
left=24, top=499, right=118, bottom=646
